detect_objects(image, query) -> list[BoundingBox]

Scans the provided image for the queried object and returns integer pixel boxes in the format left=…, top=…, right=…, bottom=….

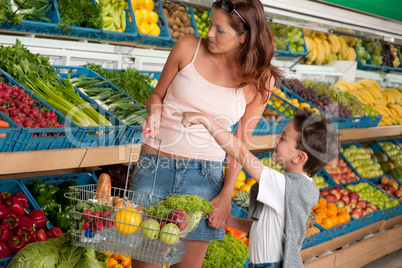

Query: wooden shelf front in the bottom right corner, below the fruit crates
left=301, top=215, right=402, bottom=268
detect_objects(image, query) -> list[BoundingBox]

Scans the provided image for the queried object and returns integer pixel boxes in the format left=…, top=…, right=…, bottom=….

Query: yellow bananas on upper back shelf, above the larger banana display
left=303, top=29, right=356, bottom=65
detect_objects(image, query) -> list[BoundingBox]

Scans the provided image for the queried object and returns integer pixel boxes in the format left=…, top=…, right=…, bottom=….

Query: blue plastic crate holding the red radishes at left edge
left=0, top=70, right=77, bottom=151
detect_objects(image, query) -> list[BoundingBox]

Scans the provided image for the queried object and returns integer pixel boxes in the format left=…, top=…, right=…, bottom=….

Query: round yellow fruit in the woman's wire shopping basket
left=114, top=207, right=142, bottom=234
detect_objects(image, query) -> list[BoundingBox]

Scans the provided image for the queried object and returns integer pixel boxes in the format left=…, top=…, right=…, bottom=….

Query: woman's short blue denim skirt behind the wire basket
left=130, top=152, right=224, bottom=241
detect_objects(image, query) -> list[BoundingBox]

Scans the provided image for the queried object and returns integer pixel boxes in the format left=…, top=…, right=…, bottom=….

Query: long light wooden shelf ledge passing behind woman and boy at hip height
left=0, top=126, right=402, bottom=176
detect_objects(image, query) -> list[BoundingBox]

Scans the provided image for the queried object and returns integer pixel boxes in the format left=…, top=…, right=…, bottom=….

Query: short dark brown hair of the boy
left=293, top=108, right=339, bottom=176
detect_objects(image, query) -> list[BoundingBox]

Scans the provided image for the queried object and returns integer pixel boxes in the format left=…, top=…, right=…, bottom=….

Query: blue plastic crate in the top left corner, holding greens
left=3, top=0, right=60, bottom=34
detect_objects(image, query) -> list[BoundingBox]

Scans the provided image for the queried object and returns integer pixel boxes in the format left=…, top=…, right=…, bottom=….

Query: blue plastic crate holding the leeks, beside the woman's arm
left=53, top=65, right=141, bottom=145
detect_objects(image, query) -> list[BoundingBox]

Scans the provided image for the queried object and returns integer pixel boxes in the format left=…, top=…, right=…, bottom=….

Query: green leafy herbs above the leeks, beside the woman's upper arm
left=85, top=63, right=152, bottom=103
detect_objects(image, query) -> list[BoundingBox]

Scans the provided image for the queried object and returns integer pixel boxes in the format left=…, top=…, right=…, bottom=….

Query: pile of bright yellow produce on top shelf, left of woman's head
left=131, top=0, right=161, bottom=36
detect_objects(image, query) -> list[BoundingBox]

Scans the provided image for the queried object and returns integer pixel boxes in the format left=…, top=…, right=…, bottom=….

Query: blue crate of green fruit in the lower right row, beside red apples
left=342, top=178, right=401, bottom=229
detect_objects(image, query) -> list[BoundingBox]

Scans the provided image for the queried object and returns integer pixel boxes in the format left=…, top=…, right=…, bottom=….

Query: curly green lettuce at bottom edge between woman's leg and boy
left=202, top=233, right=248, bottom=268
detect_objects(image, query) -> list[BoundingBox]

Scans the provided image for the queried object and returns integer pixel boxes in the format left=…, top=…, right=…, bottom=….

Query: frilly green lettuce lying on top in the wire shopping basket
left=145, top=195, right=212, bottom=231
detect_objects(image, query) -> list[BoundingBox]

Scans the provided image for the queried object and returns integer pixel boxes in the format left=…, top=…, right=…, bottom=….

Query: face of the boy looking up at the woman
left=272, top=120, right=299, bottom=170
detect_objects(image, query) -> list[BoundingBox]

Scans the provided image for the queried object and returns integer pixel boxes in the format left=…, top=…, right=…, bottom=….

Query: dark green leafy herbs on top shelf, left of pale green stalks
left=56, top=0, right=103, bottom=31
